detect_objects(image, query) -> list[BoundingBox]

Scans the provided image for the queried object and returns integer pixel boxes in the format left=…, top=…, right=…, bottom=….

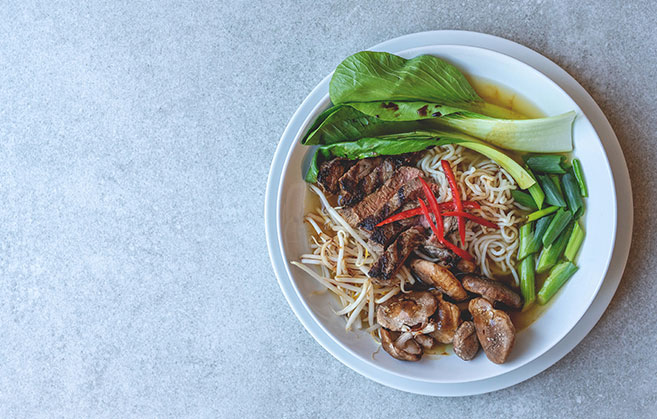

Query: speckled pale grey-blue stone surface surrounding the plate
left=0, top=0, right=657, bottom=418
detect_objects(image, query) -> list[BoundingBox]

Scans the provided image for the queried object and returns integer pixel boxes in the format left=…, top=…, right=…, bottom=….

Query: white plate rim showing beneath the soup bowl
left=265, top=31, right=633, bottom=396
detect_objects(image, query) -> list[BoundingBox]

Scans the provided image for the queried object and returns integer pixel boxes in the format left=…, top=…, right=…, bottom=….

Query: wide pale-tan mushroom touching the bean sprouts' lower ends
left=376, top=291, right=438, bottom=332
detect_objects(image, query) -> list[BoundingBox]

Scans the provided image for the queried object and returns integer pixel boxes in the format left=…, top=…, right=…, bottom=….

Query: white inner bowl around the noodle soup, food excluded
left=268, top=37, right=616, bottom=390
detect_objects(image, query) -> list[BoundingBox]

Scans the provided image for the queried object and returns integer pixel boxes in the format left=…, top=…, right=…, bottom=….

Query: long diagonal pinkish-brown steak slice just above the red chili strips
left=339, top=166, right=422, bottom=230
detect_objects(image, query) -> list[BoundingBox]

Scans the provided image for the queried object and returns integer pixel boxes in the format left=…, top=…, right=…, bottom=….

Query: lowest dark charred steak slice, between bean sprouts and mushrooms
left=368, top=226, right=424, bottom=285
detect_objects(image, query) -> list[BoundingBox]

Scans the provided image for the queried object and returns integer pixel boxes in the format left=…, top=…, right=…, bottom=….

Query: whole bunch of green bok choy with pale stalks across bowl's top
left=301, top=51, right=575, bottom=194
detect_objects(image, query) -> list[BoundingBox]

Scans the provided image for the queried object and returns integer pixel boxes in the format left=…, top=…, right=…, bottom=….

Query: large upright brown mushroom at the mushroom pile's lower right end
left=468, top=298, right=516, bottom=364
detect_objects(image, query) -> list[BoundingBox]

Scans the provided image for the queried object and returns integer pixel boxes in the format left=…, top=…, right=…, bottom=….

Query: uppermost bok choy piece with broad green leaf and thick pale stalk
left=320, top=51, right=575, bottom=153
